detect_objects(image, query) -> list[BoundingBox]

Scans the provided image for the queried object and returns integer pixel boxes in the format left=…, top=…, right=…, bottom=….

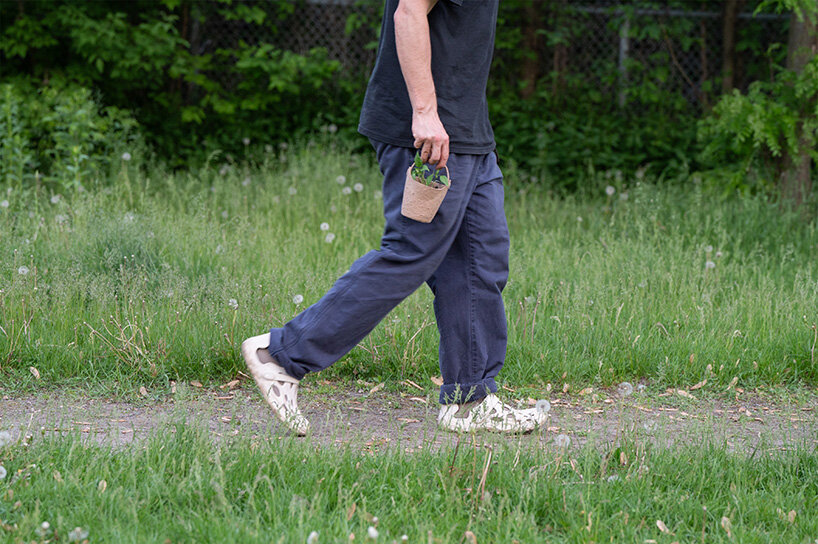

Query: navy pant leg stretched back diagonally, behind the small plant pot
left=269, top=142, right=482, bottom=379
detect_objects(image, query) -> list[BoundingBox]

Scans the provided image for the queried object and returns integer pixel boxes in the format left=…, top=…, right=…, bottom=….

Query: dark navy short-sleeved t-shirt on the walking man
left=358, top=0, right=500, bottom=154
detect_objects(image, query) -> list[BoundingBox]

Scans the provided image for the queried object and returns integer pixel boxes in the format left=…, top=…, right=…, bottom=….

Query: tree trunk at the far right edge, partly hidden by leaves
left=780, top=13, right=818, bottom=205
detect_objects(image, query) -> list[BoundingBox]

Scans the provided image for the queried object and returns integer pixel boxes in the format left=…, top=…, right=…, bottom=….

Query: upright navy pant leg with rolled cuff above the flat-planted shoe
left=428, top=150, right=509, bottom=404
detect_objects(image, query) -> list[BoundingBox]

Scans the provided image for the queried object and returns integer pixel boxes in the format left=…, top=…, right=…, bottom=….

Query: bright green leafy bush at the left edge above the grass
left=0, top=79, right=141, bottom=192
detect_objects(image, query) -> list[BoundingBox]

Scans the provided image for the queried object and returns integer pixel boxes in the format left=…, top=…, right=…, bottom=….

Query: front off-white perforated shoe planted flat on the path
left=437, top=394, right=548, bottom=434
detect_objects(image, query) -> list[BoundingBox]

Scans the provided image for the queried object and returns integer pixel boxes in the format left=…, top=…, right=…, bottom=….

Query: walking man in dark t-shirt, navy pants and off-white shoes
left=242, top=0, right=545, bottom=434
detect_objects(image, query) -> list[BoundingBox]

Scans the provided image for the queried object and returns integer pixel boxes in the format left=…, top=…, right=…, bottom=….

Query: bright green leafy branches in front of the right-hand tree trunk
left=699, top=56, right=818, bottom=189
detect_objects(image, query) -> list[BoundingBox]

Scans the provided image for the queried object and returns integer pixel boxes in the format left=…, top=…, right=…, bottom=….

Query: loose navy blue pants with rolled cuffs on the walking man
left=269, top=141, right=509, bottom=404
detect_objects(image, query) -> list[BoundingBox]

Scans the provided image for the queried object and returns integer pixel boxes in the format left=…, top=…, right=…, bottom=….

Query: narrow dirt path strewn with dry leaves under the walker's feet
left=0, top=385, right=818, bottom=452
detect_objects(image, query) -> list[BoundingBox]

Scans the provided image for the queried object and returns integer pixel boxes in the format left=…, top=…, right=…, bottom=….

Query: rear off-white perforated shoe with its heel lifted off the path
left=241, top=334, right=310, bottom=436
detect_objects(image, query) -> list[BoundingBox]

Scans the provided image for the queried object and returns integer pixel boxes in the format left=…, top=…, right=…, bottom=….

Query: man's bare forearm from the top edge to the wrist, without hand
left=394, top=0, right=437, bottom=113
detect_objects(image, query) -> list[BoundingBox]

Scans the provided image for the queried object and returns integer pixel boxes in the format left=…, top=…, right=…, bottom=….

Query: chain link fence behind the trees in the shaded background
left=191, top=0, right=788, bottom=106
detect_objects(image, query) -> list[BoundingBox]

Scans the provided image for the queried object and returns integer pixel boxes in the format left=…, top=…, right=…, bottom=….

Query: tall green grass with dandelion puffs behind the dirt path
left=0, top=142, right=818, bottom=392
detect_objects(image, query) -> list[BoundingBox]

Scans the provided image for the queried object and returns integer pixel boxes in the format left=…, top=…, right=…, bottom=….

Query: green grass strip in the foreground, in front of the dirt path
left=0, top=420, right=818, bottom=543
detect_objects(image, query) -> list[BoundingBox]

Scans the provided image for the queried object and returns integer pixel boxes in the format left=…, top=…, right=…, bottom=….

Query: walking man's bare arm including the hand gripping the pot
left=394, top=0, right=449, bottom=168
